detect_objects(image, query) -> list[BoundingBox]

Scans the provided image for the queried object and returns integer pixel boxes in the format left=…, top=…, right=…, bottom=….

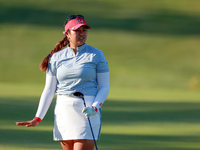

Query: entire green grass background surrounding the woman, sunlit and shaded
left=0, top=0, right=200, bottom=150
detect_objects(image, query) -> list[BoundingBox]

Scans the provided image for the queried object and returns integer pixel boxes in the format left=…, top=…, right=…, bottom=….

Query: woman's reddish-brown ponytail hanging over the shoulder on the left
left=40, top=35, right=69, bottom=72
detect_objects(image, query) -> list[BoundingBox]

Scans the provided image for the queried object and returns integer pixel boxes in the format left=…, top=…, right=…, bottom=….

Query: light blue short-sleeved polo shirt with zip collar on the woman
left=47, top=43, right=109, bottom=96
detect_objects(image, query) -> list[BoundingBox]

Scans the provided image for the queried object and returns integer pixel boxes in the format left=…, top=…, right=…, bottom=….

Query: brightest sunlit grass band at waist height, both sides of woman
left=0, top=83, right=200, bottom=103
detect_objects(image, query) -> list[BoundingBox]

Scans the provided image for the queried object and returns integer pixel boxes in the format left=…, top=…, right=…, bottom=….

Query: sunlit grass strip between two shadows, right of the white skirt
left=102, top=122, right=200, bottom=136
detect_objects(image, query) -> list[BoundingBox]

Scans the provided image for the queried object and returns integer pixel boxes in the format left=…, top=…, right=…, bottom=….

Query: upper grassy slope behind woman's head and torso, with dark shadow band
left=0, top=0, right=200, bottom=89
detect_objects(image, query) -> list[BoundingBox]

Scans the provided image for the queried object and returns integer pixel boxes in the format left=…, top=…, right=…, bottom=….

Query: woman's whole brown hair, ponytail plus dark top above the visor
left=40, top=15, right=84, bottom=72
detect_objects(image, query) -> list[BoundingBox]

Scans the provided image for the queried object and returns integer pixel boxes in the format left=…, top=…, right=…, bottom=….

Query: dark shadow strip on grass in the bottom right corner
left=98, top=134, right=200, bottom=150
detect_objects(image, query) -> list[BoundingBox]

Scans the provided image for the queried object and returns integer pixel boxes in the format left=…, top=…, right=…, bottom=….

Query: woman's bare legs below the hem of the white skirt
left=74, top=140, right=94, bottom=150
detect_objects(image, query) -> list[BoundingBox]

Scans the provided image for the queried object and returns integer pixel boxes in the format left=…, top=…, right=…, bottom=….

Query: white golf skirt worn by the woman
left=53, top=95, right=101, bottom=141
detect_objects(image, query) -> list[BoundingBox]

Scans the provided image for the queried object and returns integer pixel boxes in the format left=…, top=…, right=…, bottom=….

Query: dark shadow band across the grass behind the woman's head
left=0, top=6, right=200, bottom=35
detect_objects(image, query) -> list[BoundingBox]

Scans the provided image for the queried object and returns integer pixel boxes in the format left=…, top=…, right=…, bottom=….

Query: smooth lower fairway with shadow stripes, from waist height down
left=0, top=84, right=200, bottom=150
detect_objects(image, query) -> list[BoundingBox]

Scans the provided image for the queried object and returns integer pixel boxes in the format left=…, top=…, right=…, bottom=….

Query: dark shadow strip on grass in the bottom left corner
left=0, top=127, right=61, bottom=149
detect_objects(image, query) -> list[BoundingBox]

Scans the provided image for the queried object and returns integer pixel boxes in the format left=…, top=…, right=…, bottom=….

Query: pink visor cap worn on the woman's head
left=63, top=18, right=91, bottom=34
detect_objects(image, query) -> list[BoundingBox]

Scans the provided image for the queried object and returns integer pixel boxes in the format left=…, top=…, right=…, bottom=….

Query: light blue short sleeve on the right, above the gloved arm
left=97, top=51, right=109, bottom=73
